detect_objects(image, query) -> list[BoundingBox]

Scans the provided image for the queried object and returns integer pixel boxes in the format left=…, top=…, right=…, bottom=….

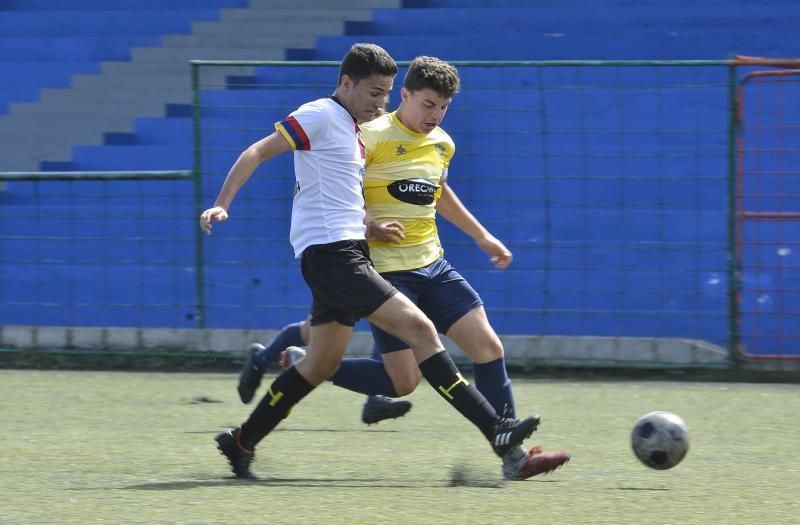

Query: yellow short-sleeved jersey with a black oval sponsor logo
left=361, top=112, right=455, bottom=273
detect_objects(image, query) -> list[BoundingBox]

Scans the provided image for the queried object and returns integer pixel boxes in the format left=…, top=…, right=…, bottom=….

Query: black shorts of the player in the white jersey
left=300, top=240, right=397, bottom=326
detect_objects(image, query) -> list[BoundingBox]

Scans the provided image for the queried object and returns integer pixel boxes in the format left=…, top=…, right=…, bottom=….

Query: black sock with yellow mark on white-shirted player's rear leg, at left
left=240, top=367, right=314, bottom=450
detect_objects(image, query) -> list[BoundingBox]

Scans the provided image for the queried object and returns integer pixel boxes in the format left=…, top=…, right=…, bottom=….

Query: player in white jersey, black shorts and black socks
left=200, top=44, right=539, bottom=478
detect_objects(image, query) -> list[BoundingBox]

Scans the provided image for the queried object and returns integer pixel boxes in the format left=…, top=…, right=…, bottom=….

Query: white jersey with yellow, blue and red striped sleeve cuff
left=275, top=98, right=366, bottom=257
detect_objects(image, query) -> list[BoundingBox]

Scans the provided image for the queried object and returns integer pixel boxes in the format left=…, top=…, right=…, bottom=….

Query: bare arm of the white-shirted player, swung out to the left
left=200, top=132, right=290, bottom=235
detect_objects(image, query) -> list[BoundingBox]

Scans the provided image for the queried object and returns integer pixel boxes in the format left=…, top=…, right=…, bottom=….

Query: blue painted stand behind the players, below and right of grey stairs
left=0, top=0, right=800, bottom=356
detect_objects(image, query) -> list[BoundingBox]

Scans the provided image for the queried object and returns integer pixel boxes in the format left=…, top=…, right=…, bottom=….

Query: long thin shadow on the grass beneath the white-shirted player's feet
left=123, top=476, right=447, bottom=490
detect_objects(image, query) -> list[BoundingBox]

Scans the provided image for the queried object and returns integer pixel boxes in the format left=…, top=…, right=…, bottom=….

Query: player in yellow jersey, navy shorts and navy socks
left=360, top=57, right=569, bottom=479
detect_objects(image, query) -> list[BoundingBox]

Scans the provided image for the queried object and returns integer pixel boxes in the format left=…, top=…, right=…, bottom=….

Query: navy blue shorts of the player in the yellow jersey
left=370, top=258, right=483, bottom=354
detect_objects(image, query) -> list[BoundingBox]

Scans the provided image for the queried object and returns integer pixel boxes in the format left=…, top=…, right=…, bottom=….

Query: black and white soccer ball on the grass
left=631, top=411, right=689, bottom=470
